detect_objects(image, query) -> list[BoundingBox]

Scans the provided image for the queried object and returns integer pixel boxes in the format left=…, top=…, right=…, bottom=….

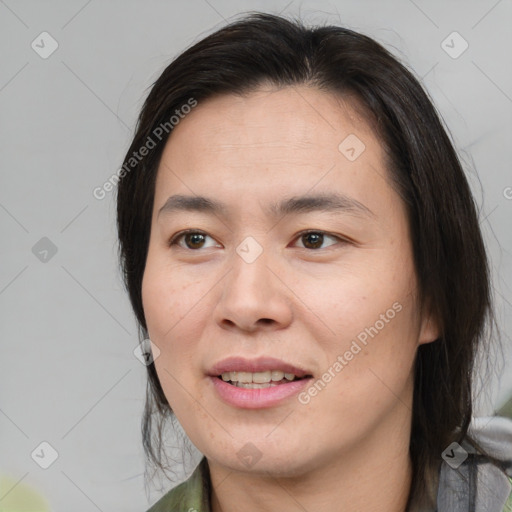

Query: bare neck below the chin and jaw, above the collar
left=208, top=404, right=412, bottom=512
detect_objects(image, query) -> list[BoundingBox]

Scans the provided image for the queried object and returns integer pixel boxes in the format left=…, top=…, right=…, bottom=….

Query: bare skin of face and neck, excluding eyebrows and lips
left=142, top=86, right=437, bottom=512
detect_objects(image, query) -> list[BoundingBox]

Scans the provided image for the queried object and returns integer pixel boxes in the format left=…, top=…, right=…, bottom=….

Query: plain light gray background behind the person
left=0, top=0, right=512, bottom=512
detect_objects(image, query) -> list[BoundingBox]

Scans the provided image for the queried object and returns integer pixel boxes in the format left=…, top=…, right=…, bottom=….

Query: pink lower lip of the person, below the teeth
left=210, top=377, right=311, bottom=409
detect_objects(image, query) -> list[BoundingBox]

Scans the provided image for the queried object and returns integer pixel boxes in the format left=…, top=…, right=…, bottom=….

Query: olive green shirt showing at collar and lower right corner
left=147, top=457, right=512, bottom=512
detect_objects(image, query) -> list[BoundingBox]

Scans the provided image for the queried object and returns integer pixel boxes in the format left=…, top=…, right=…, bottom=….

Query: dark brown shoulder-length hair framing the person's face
left=117, top=13, right=496, bottom=506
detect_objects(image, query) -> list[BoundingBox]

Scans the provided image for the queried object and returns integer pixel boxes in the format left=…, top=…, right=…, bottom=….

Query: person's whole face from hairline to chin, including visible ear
left=142, top=87, right=436, bottom=475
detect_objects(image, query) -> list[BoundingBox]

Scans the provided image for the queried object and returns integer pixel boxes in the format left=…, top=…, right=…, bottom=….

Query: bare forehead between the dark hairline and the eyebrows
left=155, top=86, right=394, bottom=215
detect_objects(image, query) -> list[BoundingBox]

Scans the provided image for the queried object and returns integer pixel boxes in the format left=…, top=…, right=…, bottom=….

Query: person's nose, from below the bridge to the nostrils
left=214, top=247, right=293, bottom=332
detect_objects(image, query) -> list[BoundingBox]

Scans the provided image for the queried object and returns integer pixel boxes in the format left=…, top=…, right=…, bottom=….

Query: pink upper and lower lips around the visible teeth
left=208, top=357, right=312, bottom=409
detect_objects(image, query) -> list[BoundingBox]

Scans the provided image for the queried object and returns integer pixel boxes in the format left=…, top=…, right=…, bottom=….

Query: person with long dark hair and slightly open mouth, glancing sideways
left=117, top=13, right=512, bottom=512
